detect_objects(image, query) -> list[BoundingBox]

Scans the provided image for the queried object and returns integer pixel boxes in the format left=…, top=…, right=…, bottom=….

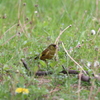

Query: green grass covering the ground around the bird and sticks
left=0, top=0, right=100, bottom=100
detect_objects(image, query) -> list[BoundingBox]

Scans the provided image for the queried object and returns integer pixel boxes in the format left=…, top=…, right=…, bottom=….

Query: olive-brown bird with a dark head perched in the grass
left=34, top=44, right=57, bottom=61
